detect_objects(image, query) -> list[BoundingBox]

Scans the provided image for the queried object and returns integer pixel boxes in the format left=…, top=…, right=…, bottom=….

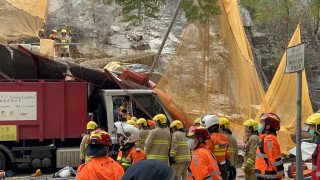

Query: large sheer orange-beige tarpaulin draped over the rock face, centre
left=157, top=0, right=264, bottom=135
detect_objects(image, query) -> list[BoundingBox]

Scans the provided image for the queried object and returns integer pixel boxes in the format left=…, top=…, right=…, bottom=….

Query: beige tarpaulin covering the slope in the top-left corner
left=0, top=0, right=48, bottom=43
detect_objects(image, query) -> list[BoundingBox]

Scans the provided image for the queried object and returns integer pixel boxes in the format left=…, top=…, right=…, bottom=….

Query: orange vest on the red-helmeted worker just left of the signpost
left=255, top=134, right=284, bottom=179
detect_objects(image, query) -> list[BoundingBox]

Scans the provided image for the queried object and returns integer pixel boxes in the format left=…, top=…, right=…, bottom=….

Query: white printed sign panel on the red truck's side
left=0, top=92, right=37, bottom=121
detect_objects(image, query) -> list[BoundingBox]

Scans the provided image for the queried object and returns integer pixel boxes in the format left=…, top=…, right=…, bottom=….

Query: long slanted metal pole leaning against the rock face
left=146, top=0, right=183, bottom=80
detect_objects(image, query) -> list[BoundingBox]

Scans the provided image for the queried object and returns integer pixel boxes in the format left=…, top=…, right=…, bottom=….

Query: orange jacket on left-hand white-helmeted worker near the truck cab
left=117, top=146, right=147, bottom=170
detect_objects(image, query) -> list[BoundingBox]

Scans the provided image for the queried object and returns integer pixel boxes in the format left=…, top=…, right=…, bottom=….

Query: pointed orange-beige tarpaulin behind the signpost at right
left=256, top=25, right=313, bottom=154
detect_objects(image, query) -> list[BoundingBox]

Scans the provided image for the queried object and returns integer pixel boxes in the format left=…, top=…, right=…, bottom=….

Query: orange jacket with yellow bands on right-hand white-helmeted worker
left=206, top=132, right=230, bottom=164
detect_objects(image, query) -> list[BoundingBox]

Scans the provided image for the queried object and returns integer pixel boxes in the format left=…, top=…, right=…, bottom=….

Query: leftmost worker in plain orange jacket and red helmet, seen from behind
left=76, top=129, right=124, bottom=180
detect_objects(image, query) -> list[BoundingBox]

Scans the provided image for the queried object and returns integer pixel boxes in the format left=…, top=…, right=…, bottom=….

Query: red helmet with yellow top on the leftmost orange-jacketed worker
left=87, top=128, right=112, bottom=146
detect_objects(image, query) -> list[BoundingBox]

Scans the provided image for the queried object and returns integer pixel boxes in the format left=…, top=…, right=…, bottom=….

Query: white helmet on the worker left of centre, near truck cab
left=114, top=121, right=140, bottom=145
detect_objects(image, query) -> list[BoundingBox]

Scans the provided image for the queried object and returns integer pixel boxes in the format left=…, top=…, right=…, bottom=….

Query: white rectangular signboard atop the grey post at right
left=285, top=44, right=305, bottom=73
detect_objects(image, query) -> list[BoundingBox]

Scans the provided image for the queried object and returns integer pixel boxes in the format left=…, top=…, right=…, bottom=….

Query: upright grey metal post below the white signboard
left=296, top=71, right=303, bottom=180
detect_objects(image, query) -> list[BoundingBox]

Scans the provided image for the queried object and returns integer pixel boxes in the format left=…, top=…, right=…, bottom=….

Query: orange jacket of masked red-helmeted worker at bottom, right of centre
left=187, top=145, right=220, bottom=180
